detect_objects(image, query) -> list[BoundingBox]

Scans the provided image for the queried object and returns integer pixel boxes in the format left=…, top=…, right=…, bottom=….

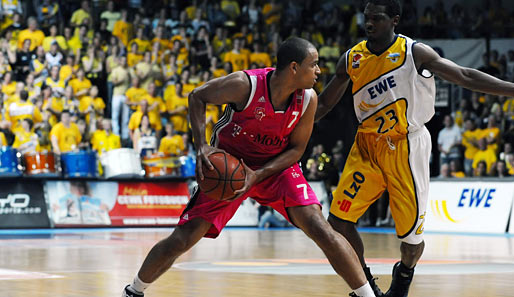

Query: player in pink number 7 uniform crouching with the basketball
left=122, top=38, right=375, bottom=297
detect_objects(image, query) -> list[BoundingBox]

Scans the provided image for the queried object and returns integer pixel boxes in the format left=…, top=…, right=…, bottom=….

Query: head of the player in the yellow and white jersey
left=364, top=4, right=398, bottom=40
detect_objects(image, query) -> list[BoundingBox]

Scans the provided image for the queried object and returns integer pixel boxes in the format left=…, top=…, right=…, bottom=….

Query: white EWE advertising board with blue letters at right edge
left=425, top=181, right=514, bottom=233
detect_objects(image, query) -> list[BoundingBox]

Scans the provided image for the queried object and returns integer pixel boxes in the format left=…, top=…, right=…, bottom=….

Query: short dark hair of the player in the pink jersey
left=277, top=37, right=316, bottom=70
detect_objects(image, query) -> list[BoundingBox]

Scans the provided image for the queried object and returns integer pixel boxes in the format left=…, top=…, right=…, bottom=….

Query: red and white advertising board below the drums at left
left=46, top=180, right=189, bottom=227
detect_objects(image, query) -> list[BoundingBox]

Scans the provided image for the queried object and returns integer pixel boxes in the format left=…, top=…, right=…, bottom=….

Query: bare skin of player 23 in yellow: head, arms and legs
left=315, top=4, right=514, bottom=268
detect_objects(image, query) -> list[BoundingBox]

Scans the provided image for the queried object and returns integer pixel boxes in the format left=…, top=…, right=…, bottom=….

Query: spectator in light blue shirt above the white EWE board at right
left=437, top=115, right=462, bottom=165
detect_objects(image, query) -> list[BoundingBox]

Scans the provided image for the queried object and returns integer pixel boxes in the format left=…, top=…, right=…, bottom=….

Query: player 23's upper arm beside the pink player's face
left=314, top=53, right=350, bottom=121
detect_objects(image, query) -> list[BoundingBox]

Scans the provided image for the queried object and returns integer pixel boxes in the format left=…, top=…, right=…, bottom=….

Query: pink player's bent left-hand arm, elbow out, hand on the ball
left=189, top=71, right=250, bottom=179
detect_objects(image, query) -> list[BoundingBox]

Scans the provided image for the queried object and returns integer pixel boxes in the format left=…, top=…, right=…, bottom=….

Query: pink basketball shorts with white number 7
left=178, top=164, right=321, bottom=238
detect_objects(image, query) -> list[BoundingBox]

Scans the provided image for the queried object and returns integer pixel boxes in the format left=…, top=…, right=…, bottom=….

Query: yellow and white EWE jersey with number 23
left=346, top=35, right=435, bottom=137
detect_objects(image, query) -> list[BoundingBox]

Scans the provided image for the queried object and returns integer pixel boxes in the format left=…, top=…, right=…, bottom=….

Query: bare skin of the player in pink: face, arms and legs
left=134, top=47, right=367, bottom=289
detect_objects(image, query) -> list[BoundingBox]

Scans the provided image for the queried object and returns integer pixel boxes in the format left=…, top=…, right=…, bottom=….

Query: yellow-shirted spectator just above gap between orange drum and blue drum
left=50, top=110, right=82, bottom=154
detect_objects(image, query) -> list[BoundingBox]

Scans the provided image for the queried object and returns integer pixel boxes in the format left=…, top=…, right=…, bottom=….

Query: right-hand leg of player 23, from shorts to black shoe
left=382, top=128, right=432, bottom=297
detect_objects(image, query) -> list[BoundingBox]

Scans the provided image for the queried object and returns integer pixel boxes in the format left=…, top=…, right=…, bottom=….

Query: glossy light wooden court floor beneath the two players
left=0, top=228, right=514, bottom=297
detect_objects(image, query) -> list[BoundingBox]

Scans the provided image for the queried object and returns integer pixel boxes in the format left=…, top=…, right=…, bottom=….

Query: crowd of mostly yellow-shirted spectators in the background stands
left=0, top=0, right=508, bottom=182
